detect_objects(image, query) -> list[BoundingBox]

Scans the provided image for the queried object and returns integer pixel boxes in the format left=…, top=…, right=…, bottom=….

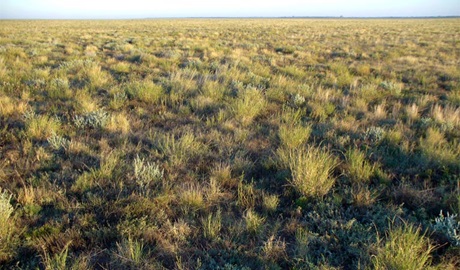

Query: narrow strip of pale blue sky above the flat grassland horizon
left=0, top=0, right=460, bottom=19
